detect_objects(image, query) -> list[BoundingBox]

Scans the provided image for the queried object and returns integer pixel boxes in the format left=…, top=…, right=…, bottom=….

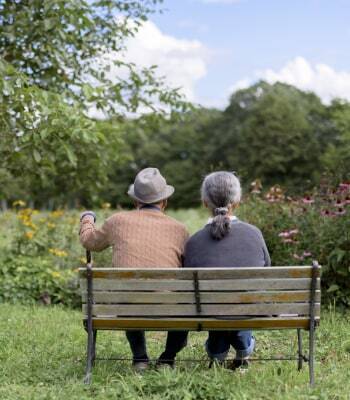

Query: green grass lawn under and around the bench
left=0, top=304, right=350, bottom=400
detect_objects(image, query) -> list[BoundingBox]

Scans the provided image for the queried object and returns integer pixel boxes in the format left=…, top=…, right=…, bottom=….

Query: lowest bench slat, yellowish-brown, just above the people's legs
left=87, top=317, right=319, bottom=331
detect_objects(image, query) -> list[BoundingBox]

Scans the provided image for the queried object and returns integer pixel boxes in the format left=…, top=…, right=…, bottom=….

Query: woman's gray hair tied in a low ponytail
left=201, top=171, right=242, bottom=240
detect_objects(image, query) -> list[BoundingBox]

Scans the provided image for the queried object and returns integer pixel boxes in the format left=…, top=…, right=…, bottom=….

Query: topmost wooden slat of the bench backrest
left=79, top=266, right=320, bottom=280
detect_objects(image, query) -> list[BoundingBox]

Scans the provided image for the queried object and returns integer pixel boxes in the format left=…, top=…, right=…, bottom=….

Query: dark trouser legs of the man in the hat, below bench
left=126, top=330, right=188, bottom=364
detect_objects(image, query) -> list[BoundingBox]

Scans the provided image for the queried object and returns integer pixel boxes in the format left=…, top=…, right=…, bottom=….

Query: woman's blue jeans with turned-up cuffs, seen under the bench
left=205, top=331, right=255, bottom=361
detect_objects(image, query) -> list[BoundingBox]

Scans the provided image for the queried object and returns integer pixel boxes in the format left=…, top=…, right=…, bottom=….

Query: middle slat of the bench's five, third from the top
left=82, top=290, right=321, bottom=304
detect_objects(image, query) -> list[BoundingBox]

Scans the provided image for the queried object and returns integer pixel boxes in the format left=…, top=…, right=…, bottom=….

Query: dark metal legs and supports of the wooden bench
left=84, top=251, right=320, bottom=386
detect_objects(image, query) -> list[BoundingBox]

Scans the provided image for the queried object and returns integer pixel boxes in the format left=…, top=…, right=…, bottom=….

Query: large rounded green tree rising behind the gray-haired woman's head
left=210, top=82, right=330, bottom=188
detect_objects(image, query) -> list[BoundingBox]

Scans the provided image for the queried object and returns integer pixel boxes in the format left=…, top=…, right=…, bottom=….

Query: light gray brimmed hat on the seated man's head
left=128, top=168, right=175, bottom=204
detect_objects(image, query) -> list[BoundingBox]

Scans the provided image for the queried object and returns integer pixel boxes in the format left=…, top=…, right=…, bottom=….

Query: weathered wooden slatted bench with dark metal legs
left=79, top=254, right=321, bottom=385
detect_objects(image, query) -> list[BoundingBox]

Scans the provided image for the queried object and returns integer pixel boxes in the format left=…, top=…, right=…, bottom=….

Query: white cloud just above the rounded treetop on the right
left=230, top=57, right=350, bottom=103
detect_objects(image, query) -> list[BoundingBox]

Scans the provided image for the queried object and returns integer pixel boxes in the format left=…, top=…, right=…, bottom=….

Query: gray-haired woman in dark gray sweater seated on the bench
left=184, top=171, right=270, bottom=369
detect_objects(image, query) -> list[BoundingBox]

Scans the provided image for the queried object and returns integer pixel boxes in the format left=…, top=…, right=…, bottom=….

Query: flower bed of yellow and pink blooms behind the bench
left=0, top=182, right=350, bottom=306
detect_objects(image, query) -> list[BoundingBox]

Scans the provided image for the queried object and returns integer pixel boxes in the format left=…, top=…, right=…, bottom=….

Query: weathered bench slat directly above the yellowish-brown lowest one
left=83, top=303, right=320, bottom=317
